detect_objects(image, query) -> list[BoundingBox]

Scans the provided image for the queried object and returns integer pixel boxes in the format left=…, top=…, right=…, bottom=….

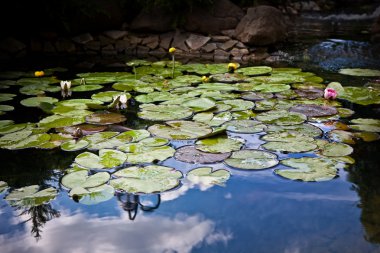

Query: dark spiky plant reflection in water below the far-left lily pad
left=17, top=203, right=61, bottom=241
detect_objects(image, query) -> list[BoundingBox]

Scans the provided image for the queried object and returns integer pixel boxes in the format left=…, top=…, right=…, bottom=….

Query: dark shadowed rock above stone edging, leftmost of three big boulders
left=130, top=7, right=174, bottom=32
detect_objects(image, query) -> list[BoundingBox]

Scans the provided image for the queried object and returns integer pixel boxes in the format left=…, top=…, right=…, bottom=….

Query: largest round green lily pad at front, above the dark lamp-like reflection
left=110, top=165, right=183, bottom=194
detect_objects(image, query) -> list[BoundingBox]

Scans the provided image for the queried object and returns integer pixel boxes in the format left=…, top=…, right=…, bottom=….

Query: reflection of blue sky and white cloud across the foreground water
left=0, top=172, right=378, bottom=253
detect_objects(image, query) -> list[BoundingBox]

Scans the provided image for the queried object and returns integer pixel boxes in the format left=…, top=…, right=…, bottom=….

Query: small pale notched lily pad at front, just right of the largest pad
left=186, top=167, right=231, bottom=186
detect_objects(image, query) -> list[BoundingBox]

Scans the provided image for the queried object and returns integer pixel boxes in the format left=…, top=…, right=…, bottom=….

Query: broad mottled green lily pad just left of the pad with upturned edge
left=148, top=120, right=212, bottom=140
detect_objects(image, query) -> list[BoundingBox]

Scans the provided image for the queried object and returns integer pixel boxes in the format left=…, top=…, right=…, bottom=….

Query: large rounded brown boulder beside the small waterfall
left=235, top=5, right=287, bottom=46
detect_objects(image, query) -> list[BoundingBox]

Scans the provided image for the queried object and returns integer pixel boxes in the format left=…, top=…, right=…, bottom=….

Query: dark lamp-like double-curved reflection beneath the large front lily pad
left=116, top=192, right=161, bottom=220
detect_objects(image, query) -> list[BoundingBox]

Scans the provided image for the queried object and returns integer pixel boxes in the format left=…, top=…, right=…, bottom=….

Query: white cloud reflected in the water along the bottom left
left=0, top=213, right=232, bottom=253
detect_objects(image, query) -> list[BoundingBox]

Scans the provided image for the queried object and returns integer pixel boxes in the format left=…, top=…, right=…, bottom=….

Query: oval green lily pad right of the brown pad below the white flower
left=137, top=104, right=193, bottom=121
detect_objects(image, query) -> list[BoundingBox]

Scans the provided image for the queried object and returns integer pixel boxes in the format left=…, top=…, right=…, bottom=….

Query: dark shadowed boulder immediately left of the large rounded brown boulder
left=184, top=0, right=244, bottom=35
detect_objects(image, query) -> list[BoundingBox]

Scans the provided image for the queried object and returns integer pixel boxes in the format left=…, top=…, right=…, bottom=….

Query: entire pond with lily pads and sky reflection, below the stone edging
left=0, top=38, right=380, bottom=253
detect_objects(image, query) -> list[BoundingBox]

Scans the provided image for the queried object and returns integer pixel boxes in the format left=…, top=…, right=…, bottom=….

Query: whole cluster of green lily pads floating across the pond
left=0, top=58, right=380, bottom=205
